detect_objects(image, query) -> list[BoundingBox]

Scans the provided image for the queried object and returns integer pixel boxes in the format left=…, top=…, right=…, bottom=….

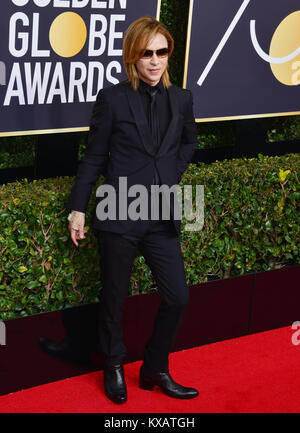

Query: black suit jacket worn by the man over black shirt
left=67, top=81, right=198, bottom=234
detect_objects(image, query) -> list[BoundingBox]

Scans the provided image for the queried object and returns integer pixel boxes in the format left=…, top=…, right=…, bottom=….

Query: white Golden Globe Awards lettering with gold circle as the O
left=0, top=0, right=127, bottom=106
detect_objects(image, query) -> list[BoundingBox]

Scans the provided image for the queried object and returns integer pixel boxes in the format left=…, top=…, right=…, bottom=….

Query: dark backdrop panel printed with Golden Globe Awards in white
left=0, top=0, right=160, bottom=136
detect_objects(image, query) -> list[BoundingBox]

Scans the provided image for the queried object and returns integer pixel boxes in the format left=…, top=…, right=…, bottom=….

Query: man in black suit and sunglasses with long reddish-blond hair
left=68, top=17, right=198, bottom=403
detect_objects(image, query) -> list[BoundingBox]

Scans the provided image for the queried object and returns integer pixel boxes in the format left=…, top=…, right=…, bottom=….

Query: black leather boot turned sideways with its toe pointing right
left=140, top=366, right=199, bottom=399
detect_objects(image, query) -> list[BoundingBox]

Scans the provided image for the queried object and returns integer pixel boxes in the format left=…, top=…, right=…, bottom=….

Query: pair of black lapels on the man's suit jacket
left=127, top=84, right=179, bottom=156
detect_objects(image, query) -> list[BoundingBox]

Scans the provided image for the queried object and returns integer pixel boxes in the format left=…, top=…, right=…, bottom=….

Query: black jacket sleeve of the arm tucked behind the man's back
left=177, top=91, right=198, bottom=183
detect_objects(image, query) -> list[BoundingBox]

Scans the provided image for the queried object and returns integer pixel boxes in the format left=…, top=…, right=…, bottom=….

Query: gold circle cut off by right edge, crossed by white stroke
left=270, top=11, right=300, bottom=86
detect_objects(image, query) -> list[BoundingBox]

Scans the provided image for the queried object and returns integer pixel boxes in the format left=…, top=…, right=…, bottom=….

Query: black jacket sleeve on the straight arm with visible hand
left=67, top=90, right=112, bottom=212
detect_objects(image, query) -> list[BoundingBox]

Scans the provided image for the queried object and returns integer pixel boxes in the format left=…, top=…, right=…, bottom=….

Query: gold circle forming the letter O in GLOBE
left=49, top=12, right=87, bottom=57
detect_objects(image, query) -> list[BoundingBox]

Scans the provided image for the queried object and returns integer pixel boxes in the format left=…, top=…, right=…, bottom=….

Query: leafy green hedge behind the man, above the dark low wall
left=0, top=154, right=300, bottom=319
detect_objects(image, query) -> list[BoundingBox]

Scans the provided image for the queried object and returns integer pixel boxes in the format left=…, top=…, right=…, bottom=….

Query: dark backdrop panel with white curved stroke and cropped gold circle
left=184, top=0, right=300, bottom=121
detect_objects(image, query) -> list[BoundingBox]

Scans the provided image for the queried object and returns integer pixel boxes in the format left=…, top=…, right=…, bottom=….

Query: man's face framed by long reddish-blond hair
left=135, top=33, right=168, bottom=86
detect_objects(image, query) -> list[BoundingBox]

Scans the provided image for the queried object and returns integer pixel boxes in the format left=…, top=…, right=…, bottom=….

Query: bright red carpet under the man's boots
left=0, top=327, right=300, bottom=413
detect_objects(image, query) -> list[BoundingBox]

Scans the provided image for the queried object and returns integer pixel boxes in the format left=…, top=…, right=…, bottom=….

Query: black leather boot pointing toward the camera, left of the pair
left=104, top=365, right=127, bottom=404
